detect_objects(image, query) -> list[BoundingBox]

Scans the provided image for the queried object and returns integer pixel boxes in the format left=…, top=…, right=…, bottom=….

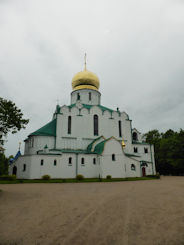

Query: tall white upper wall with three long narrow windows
left=56, top=106, right=132, bottom=152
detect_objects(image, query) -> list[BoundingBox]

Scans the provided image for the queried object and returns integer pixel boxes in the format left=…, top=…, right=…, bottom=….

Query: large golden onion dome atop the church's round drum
left=72, top=69, right=100, bottom=90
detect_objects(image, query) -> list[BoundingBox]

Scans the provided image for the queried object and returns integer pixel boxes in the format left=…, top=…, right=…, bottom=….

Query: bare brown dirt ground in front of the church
left=0, top=177, right=184, bottom=245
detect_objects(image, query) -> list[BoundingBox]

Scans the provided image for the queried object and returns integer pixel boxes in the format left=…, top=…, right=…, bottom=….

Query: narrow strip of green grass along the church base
left=0, top=176, right=158, bottom=184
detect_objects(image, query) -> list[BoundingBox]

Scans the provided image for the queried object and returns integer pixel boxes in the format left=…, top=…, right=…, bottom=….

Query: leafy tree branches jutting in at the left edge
left=0, top=97, right=29, bottom=142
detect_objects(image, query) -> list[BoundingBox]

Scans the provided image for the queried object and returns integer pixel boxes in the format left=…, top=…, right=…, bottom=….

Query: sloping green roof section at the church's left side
left=29, top=119, right=56, bottom=136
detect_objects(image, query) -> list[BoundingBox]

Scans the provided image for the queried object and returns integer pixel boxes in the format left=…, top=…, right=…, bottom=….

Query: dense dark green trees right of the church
left=145, top=129, right=184, bottom=175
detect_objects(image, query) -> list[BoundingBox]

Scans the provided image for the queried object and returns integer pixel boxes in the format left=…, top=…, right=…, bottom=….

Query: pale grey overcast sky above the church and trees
left=0, top=0, right=184, bottom=155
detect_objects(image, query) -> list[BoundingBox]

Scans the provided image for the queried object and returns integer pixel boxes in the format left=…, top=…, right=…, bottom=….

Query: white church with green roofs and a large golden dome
left=9, top=60, right=156, bottom=179
